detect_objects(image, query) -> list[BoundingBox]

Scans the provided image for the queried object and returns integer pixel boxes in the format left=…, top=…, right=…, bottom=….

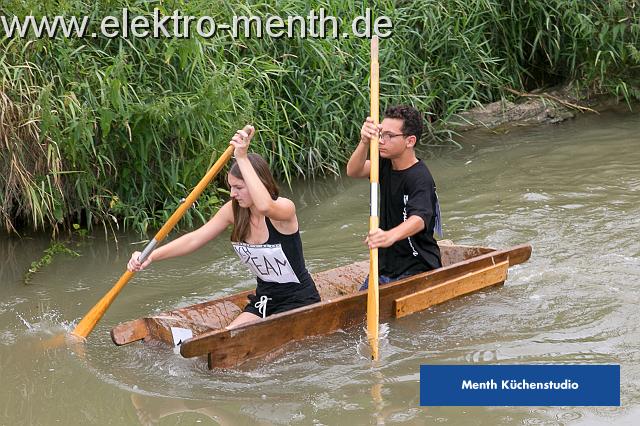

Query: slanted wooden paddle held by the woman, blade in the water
left=71, top=126, right=251, bottom=339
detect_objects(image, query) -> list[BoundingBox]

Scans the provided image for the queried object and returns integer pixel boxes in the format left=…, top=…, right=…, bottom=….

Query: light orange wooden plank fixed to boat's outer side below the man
left=395, top=260, right=509, bottom=318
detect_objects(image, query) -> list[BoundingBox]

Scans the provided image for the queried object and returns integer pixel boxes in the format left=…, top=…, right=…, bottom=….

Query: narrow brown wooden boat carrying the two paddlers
left=111, top=242, right=531, bottom=368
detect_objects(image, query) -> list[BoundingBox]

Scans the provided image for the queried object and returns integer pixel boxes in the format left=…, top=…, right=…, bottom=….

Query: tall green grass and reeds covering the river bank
left=0, top=0, right=640, bottom=233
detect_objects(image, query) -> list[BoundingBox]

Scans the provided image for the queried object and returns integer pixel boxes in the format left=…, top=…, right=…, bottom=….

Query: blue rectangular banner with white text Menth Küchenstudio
left=420, top=364, right=620, bottom=406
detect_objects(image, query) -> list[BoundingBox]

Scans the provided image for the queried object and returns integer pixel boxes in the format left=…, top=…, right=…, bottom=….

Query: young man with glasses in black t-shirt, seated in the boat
left=347, top=106, right=442, bottom=289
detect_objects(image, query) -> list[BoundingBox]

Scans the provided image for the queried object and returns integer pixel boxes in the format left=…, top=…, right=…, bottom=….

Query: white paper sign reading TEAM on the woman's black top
left=232, top=243, right=300, bottom=283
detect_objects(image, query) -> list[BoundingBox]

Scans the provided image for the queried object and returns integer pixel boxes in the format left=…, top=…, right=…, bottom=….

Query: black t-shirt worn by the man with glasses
left=378, top=158, right=442, bottom=278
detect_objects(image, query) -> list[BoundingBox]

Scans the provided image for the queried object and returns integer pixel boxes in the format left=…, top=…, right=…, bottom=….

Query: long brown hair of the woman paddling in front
left=229, top=152, right=280, bottom=242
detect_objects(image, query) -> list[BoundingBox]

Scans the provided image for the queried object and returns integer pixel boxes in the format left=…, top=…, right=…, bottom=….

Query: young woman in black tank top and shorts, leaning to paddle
left=127, top=127, right=320, bottom=327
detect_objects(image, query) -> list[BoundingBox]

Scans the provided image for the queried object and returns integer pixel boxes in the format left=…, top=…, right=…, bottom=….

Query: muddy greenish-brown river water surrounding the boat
left=0, top=113, right=640, bottom=425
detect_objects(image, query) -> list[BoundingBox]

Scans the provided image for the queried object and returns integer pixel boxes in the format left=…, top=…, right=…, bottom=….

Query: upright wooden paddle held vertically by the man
left=367, top=36, right=380, bottom=361
